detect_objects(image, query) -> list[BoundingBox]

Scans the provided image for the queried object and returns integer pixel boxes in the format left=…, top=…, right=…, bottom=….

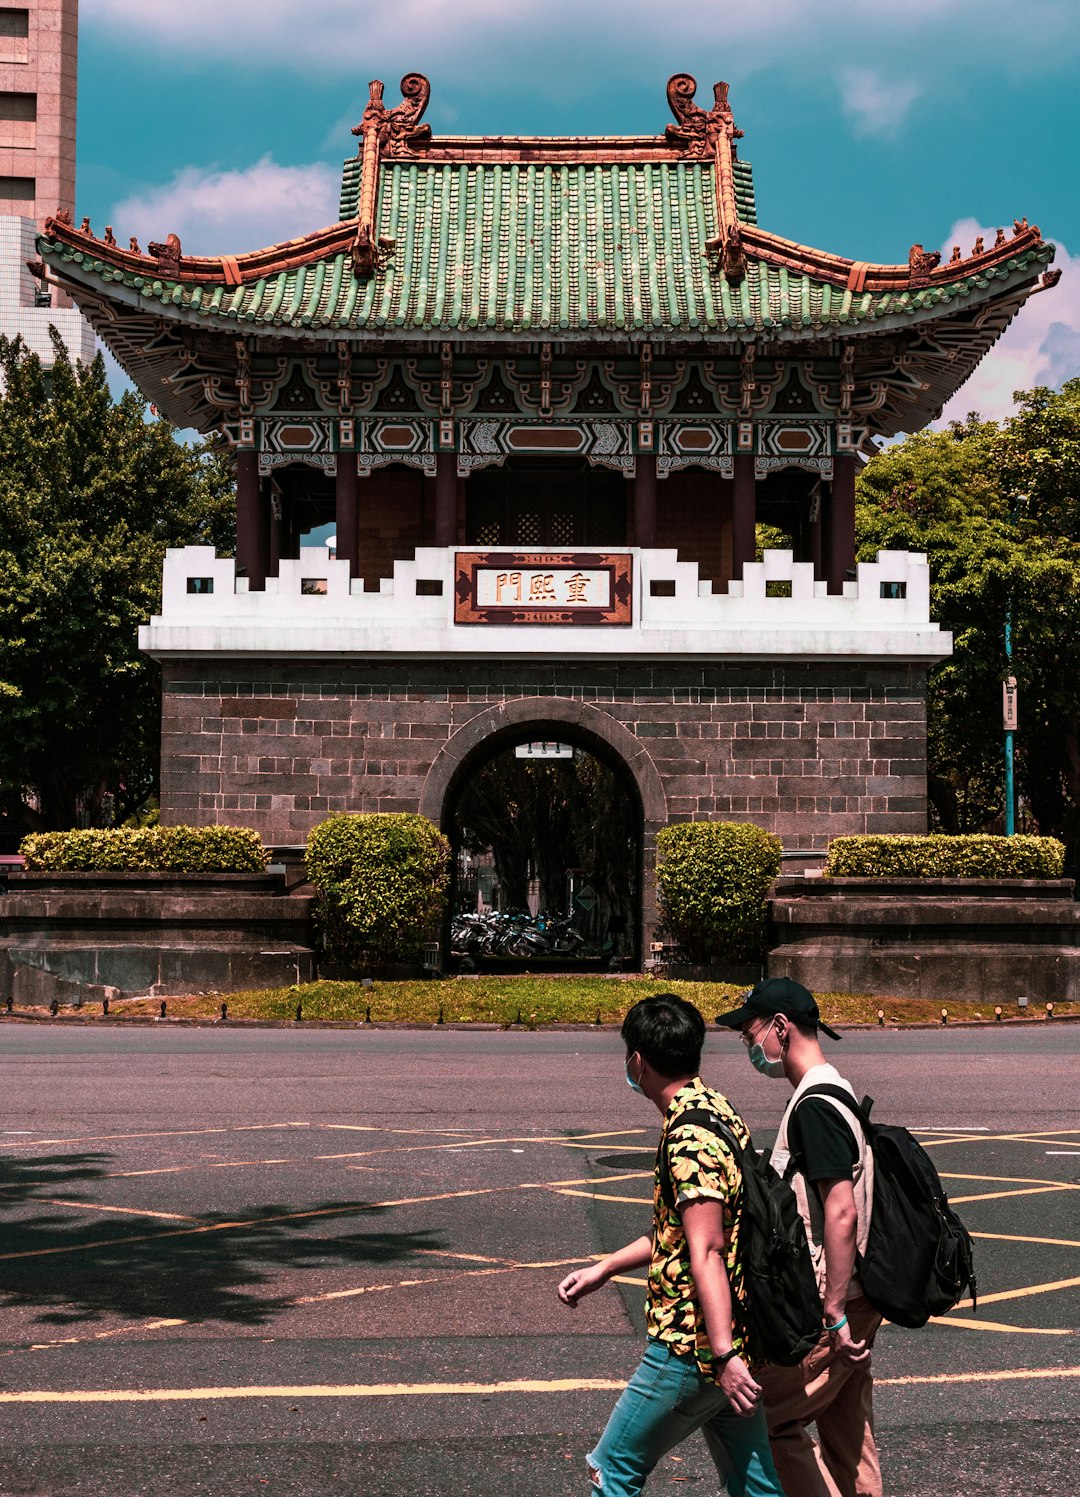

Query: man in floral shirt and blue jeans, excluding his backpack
left=559, top=993, right=783, bottom=1497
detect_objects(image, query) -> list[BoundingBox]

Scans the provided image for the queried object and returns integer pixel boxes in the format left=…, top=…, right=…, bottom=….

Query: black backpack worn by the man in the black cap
left=795, top=1084, right=978, bottom=1328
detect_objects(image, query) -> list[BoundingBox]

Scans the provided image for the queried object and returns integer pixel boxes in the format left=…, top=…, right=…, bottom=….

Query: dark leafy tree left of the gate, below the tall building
left=0, top=332, right=235, bottom=835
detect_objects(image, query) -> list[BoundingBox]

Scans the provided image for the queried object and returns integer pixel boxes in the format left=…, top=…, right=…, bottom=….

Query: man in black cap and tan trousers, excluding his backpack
left=718, top=978, right=881, bottom=1497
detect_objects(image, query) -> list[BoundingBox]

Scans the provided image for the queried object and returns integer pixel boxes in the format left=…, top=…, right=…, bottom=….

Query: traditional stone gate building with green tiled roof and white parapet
left=36, top=75, right=1053, bottom=940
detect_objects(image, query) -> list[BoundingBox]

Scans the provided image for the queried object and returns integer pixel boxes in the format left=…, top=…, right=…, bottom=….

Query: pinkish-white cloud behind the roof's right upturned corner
left=941, top=219, right=1080, bottom=422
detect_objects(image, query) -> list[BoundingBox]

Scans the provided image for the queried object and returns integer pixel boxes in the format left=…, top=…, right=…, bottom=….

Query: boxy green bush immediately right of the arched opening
left=656, top=822, right=780, bottom=961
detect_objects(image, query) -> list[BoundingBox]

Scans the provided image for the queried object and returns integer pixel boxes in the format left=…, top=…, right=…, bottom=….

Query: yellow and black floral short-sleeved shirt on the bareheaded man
left=646, top=1076, right=752, bottom=1382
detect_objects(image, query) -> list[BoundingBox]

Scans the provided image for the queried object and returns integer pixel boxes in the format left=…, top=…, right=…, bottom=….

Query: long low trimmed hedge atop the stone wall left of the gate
left=19, top=826, right=267, bottom=873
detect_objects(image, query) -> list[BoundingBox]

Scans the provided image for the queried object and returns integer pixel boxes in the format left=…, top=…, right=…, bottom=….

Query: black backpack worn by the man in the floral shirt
left=656, top=1108, right=821, bottom=1367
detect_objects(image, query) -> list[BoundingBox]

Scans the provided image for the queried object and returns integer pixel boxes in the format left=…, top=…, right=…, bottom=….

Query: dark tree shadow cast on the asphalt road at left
left=0, top=1154, right=445, bottom=1325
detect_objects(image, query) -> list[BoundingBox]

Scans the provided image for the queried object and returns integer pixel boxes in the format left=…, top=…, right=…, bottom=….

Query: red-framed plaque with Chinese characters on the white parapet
left=454, top=551, right=632, bottom=624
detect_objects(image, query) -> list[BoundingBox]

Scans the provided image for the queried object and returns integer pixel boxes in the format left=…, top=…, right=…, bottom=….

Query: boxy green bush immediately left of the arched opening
left=306, top=811, right=449, bottom=961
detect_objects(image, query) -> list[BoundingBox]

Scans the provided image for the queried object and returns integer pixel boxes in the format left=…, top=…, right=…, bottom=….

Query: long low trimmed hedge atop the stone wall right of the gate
left=824, top=832, right=1065, bottom=879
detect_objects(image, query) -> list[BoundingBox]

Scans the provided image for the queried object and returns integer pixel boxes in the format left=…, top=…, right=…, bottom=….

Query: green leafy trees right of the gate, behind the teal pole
left=857, top=379, right=1080, bottom=858
